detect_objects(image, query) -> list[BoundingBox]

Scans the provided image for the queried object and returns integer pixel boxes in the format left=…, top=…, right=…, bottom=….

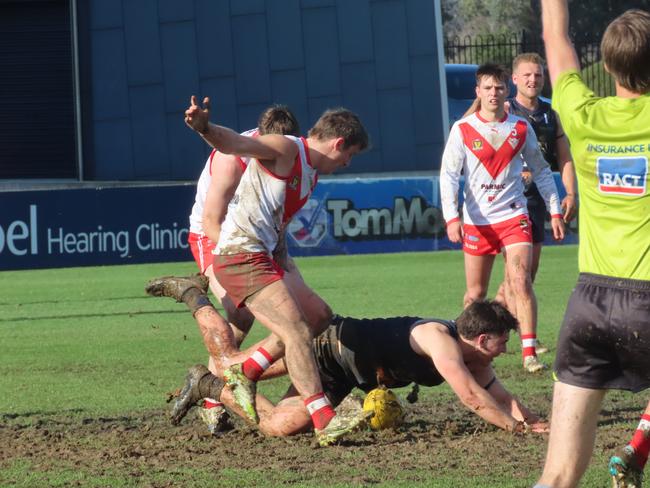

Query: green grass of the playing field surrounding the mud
left=0, top=246, right=643, bottom=487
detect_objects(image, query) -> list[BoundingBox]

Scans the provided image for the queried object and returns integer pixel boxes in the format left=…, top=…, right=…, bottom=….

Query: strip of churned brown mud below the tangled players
left=0, top=396, right=636, bottom=487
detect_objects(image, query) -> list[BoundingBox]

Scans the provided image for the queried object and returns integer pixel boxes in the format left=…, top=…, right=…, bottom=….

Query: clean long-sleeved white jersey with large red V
left=440, top=112, right=562, bottom=225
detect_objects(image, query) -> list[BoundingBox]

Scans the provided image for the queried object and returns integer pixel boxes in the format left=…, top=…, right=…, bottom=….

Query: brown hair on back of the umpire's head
left=600, top=9, right=650, bottom=94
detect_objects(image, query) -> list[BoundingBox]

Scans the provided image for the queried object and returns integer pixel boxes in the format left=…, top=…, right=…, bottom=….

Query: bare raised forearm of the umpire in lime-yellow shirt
left=542, top=0, right=580, bottom=85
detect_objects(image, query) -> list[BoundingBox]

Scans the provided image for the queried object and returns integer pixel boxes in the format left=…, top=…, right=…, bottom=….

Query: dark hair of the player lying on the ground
left=456, top=300, right=519, bottom=339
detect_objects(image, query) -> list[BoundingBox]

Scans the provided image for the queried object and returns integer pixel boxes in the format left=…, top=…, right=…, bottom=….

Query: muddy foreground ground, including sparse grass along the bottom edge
left=0, top=388, right=639, bottom=487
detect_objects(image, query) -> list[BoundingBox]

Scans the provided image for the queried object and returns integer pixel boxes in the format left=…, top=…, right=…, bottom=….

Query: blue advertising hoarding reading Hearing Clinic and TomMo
left=0, top=175, right=577, bottom=270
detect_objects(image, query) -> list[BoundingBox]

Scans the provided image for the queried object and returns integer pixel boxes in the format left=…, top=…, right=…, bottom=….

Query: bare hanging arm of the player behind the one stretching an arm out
left=203, top=153, right=244, bottom=243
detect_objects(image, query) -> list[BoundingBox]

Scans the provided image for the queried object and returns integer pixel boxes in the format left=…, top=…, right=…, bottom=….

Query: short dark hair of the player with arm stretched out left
left=309, top=108, right=370, bottom=151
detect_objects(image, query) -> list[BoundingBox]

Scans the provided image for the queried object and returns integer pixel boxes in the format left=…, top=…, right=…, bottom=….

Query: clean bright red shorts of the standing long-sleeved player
left=463, top=214, right=533, bottom=256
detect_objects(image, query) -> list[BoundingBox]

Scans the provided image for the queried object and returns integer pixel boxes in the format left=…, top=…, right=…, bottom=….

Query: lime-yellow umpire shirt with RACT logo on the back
left=553, top=72, right=650, bottom=280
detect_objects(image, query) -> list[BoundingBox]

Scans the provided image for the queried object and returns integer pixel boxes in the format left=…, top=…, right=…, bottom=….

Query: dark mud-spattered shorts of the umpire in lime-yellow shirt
left=555, top=273, right=650, bottom=392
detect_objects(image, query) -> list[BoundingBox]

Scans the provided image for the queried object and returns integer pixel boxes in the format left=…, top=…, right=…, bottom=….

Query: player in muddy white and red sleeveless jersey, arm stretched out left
left=185, top=97, right=368, bottom=445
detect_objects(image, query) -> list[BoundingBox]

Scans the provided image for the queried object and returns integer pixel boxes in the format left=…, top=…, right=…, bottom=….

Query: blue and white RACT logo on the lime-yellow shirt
left=596, top=157, right=648, bottom=195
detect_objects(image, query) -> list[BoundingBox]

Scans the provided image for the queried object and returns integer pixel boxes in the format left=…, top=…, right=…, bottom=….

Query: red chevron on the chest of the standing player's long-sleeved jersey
left=459, top=120, right=526, bottom=178
